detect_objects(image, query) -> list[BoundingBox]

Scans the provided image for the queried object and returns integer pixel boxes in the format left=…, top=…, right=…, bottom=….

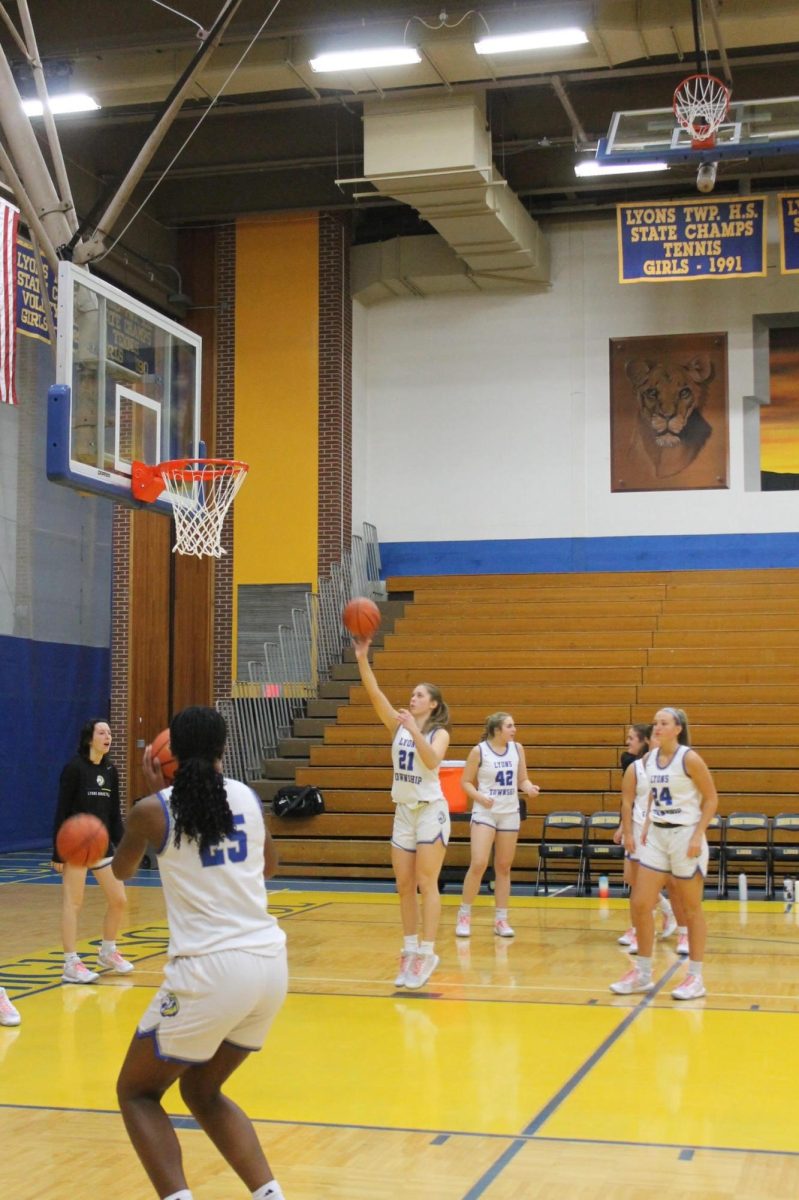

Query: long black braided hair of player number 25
left=169, top=706, right=233, bottom=853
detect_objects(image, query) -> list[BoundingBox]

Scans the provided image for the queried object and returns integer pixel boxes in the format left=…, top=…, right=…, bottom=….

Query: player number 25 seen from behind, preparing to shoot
left=113, top=707, right=288, bottom=1200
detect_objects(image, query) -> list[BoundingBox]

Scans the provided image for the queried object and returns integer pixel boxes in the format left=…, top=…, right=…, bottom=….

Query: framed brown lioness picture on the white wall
left=611, top=334, right=729, bottom=492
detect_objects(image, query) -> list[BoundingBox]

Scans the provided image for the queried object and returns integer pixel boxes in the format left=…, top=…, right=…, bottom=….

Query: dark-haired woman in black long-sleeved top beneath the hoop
left=53, top=718, right=133, bottom=983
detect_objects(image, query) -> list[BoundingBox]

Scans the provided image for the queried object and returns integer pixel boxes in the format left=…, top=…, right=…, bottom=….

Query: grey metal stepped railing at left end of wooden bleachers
left=217, top=522, right=385, bottom=780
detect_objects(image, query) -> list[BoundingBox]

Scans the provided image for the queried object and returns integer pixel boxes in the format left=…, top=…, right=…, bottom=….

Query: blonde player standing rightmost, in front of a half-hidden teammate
left=611, top=708, right=719, bottom=1000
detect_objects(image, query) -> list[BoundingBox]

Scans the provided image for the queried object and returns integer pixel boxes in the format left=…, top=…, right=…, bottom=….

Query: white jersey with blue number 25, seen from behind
left=153, top=779, right=286, bottom=958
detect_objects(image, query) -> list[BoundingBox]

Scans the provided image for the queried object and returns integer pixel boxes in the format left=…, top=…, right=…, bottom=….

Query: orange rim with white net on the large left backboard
left=131, top=458, right=250, bottom=558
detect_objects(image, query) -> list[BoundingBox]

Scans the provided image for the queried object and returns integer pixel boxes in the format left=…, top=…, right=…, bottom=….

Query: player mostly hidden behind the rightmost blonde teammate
left=614, top=725, right=689, bottom=954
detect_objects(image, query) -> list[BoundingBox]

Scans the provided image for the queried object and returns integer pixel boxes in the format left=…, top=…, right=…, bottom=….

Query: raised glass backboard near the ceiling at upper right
left=596, top=96, right=799, bottom=166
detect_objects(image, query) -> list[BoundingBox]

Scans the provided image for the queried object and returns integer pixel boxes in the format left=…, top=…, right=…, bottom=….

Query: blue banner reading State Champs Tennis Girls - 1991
left=617, top=196, right=767, bottom=283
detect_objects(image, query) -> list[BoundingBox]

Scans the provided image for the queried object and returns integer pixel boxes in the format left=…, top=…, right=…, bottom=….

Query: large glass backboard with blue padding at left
left=47, top=263, right=202, bottom=512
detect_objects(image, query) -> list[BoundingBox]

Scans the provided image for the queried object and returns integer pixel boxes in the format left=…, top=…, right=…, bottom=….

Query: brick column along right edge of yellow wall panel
left=318, top=212, right=353, bottom=575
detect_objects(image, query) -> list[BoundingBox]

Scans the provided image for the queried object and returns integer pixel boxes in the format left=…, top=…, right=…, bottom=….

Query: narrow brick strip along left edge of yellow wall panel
left=209, top=226, right=236, bottom=703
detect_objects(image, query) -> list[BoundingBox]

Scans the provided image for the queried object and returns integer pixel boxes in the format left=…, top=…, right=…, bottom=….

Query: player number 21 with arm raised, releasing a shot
left=354, top=638, right=450, bottom=990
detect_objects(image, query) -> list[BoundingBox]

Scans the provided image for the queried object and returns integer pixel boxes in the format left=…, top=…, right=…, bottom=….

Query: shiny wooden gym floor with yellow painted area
left=0, top=854, right=799, bottom=1200
